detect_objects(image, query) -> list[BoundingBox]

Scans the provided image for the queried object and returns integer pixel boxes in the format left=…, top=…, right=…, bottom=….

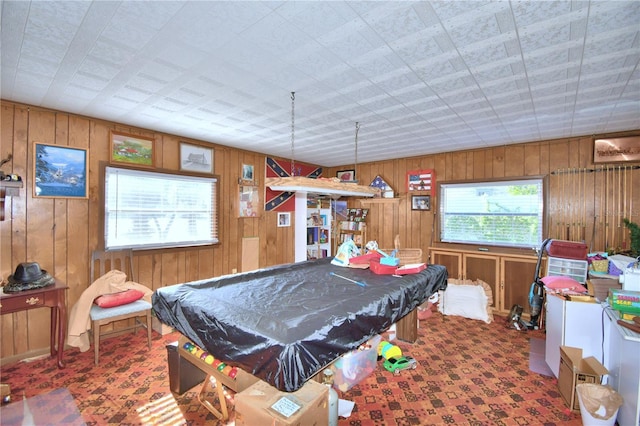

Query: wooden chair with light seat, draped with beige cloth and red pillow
left=90, top=250, right=151, bottom=365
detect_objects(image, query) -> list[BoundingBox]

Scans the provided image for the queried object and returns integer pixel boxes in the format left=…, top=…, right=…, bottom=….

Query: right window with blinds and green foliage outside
left=440, top=178, right=544, bottom=248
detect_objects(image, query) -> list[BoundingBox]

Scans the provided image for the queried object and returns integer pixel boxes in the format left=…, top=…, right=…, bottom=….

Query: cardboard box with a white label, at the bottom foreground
left=235, top=380, right=329, bottom=426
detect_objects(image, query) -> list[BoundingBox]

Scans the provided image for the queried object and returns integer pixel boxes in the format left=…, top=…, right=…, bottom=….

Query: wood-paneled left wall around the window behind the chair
left=0, top=101, right=294, bottom=362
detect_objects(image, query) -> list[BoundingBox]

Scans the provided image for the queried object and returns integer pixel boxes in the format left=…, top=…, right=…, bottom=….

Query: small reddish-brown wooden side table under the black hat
left=0, top=280, right=68, bottom=368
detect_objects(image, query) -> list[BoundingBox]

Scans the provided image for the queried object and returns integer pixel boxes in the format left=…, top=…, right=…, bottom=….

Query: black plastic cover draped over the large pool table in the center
left=152, top=258, right=447, bottom=392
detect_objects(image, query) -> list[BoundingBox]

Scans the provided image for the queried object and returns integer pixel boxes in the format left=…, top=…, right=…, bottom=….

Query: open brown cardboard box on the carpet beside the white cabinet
left=558, top=346, right=609, bottom=412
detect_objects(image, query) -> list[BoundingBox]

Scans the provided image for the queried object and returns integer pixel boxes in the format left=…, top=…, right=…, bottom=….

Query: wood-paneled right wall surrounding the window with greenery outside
left=325, top=135, right=640, bottom=256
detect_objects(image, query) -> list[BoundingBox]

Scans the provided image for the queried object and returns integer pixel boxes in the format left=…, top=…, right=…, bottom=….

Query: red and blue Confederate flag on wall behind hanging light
left=264, top=157, right=322, bottom=212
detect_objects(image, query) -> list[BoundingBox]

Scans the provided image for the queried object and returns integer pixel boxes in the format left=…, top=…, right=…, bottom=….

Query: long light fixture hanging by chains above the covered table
left=265, top=92, right=380, bottom=198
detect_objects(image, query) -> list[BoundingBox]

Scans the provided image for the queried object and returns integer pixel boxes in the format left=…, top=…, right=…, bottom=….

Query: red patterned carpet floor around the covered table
left=0, top=313, right=582, bottom=426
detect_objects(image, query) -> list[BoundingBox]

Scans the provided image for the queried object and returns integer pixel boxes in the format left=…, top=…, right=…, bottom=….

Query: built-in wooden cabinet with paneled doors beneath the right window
left=429, top=247, right=538, bottom=317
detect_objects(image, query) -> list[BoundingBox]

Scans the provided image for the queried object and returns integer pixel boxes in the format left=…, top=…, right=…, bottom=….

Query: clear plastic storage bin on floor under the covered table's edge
left=331, top=335, right=382, bottom=392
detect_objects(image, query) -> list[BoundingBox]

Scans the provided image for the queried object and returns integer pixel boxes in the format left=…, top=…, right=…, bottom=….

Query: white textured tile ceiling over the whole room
left=1, top=0, right=640, bottom=166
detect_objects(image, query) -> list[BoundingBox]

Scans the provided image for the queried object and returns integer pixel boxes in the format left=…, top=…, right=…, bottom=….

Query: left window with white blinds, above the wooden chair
left=104, top=167, right=218, bottom=250
